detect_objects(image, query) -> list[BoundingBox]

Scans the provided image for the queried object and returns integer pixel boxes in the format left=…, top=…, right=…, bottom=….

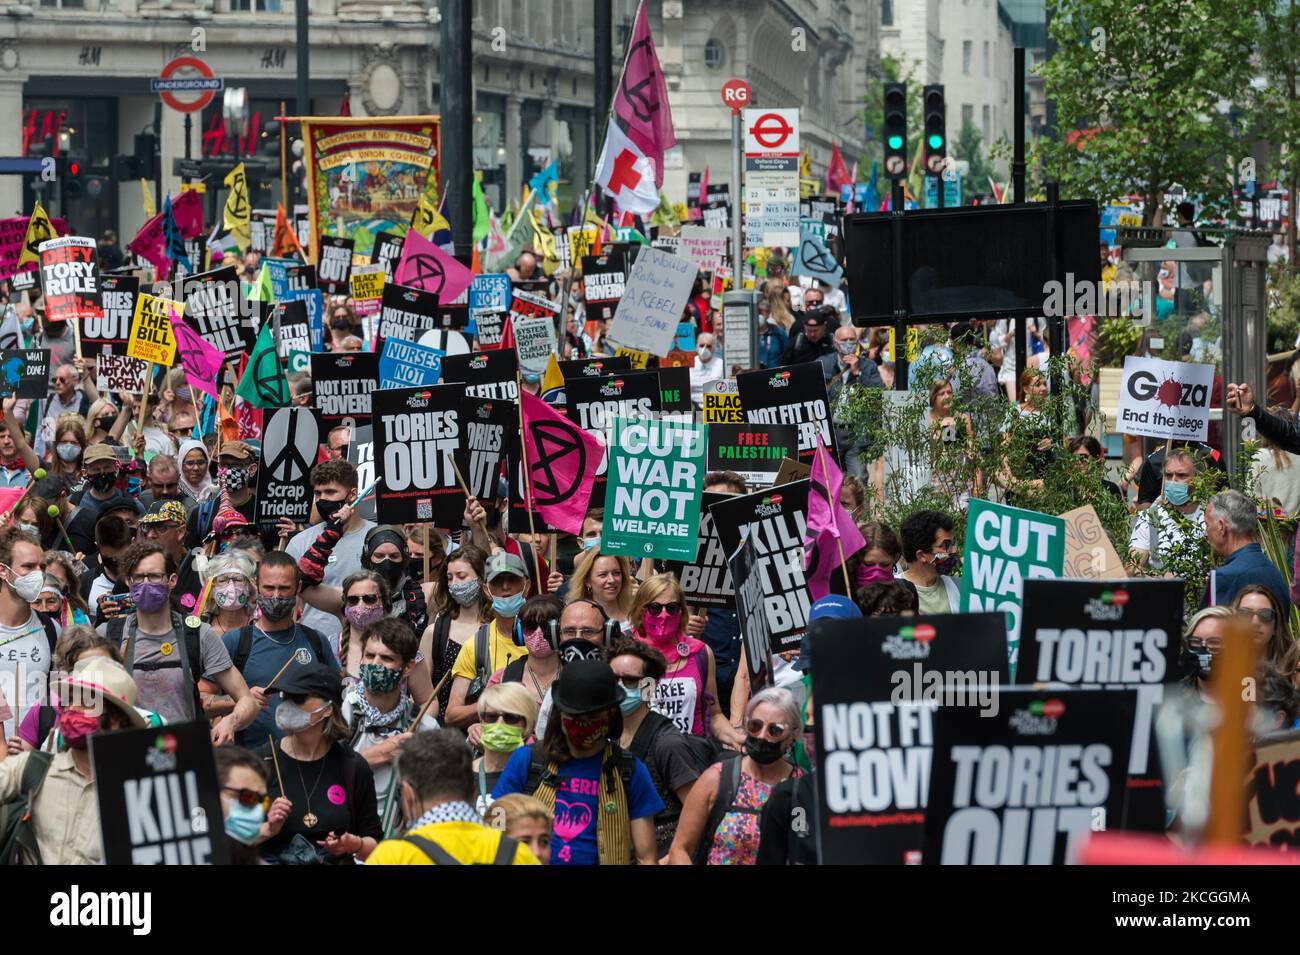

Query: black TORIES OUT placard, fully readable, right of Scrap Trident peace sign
left=371, top=385, right=465, bottom=528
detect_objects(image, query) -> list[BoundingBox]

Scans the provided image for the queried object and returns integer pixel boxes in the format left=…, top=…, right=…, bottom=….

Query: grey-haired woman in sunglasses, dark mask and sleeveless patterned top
left=668, top=686, right=803, bottom=865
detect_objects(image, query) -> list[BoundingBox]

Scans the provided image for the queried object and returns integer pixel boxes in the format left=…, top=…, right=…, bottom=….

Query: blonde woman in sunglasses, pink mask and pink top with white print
left=629, top=573, right=745, bottom=746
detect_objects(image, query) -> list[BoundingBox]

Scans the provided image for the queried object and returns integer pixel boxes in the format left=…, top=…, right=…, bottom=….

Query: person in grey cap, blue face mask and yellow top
left=443, top=552, right=528, bottom=728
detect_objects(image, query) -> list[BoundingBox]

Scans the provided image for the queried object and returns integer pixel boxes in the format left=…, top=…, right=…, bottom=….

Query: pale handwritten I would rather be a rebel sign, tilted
left=610, top=248, right=699, bottom=357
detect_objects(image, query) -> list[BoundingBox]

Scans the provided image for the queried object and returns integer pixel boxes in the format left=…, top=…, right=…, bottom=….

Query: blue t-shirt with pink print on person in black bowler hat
left=491, top=743, right=663, bottom=865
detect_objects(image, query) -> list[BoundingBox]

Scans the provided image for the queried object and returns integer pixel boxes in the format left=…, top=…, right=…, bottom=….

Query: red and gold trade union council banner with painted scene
left=302, top=116, right=442, bottom=257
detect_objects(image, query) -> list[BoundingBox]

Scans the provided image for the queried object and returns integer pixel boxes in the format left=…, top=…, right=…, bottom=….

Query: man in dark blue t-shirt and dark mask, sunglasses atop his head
left=221, top=551, right=338, bottom=750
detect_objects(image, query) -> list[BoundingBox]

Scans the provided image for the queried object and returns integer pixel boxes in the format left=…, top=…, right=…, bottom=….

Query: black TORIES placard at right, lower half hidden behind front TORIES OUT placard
left=1017, top=579, right=1187, bottom=833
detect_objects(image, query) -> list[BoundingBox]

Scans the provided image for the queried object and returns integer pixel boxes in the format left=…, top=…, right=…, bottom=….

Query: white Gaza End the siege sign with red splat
left=1115, top=355, right=1214, bottom=440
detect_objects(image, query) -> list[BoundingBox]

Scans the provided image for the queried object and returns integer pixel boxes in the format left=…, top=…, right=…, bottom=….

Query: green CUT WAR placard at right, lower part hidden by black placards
left=961, top=499, right=1065, bottom=683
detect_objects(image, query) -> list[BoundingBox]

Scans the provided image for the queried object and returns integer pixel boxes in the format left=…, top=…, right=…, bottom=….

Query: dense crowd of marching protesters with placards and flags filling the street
left=0, top=3, right=1300, bottom=924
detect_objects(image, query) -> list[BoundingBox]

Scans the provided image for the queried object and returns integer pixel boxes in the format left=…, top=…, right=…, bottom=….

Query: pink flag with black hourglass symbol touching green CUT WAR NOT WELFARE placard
left=519, top=390, right=605, bottom=534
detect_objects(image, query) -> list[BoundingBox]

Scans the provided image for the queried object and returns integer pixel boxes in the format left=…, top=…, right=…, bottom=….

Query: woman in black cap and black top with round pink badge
left=261, top=665, right=384, bottom=865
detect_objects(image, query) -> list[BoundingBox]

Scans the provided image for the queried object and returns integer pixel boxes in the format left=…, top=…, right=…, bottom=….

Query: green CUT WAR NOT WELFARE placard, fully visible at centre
left=601, top=418, right=705, bottom=561
